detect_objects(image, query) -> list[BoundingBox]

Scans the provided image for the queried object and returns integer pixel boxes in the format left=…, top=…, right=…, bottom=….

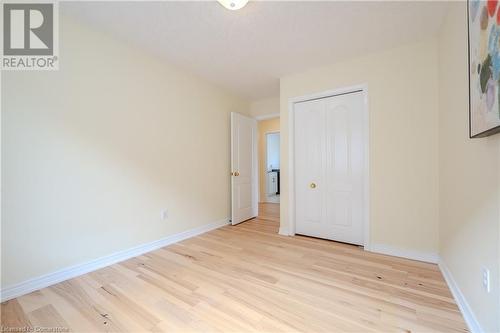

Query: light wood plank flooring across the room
left=1, top=204, right=467, bottom=332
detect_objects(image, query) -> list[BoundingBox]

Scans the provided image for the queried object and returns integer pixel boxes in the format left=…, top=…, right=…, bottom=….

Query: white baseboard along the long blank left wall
left=0, top=218, right=229, bottom=302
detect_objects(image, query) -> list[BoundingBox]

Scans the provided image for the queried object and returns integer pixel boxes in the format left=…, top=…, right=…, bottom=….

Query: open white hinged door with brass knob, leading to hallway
left=231, top=112, right=258, bottom=225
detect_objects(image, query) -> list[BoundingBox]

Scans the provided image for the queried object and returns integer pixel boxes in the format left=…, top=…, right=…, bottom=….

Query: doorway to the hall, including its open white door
left=230, top=112, right=281, bottom=227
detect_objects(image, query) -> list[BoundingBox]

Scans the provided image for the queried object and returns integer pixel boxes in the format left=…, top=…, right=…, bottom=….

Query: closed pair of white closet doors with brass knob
left=294, top=92, right=366, bottom=245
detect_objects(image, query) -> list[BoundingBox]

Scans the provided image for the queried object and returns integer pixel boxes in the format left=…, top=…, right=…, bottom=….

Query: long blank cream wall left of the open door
left=1, top=14, right=248, bottom=288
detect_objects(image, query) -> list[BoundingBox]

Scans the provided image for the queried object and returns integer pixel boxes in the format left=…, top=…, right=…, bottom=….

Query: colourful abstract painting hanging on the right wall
left=468, top=0, right=500, bottom=138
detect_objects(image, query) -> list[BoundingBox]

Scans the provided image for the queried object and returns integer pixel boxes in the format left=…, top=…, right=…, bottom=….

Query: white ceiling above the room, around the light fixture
left=60, top=1, right=447, bottom=100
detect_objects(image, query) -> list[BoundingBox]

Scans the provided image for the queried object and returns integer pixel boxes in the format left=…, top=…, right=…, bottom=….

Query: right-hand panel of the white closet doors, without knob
left=324, top=92, right=364, bottom=244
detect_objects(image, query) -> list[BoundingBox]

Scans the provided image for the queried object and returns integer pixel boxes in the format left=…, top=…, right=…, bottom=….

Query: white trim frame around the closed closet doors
left=286, top=83, right=370, bottom=251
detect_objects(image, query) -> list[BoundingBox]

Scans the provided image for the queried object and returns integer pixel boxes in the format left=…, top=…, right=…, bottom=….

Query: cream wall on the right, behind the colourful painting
left=439, top=3, right=500, bottom=332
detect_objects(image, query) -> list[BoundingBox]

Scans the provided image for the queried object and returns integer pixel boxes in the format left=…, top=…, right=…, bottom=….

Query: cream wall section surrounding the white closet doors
left=280, top=40, right=438, bottom=256
